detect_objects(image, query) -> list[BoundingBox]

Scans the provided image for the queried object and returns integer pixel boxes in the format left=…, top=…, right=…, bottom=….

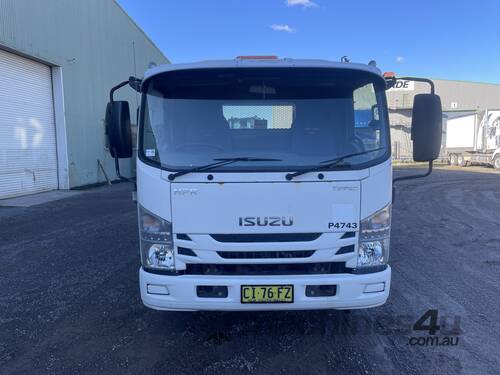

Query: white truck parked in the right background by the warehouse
left=445, top=109, right=500, bottom=169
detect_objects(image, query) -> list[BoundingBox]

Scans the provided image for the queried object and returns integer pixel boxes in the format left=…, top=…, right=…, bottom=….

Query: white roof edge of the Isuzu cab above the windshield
left=143, top=58, right=382, bottom=82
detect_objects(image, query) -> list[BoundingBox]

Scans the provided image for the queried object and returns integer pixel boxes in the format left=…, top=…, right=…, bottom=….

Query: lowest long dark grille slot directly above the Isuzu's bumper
left=184, top=262, right=351, bottom=276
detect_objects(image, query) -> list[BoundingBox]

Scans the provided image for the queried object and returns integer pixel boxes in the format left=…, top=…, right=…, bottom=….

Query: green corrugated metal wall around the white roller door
left=0, top=0, right=168, bottom=187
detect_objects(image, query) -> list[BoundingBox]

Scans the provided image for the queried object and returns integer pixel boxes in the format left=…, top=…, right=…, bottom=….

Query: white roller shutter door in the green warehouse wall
left=0, top=50, right=58, bottom=199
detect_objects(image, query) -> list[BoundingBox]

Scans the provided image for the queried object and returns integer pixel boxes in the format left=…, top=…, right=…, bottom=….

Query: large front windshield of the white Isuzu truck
left=140, top=68, right=389, bottom=171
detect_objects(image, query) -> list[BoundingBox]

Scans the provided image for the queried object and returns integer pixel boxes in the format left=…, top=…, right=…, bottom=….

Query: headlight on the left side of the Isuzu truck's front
left=139, top=205, right=175, bottom=271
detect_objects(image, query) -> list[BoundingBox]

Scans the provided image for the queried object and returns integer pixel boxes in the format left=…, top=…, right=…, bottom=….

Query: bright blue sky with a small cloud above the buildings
left=118, top=0, right=500, bottom=83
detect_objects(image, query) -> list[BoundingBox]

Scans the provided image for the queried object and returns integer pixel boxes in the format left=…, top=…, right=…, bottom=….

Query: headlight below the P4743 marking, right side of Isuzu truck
left=357, top=204, right=391, bottom=268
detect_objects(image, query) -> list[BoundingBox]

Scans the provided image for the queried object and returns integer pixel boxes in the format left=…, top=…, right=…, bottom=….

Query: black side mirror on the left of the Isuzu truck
left=105, top=101, right=132, bottom=158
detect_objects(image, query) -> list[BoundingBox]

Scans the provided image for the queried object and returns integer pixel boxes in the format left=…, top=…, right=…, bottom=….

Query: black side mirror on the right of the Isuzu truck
left=411, top=94, right=443, bottom=161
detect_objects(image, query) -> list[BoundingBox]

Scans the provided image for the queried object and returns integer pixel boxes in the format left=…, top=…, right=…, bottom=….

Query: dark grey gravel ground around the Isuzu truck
left=0, top=168, right=500, bottom=374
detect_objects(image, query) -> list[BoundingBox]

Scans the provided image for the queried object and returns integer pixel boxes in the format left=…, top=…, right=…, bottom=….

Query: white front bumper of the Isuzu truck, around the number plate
left=139, top=267, right=391, bottom=311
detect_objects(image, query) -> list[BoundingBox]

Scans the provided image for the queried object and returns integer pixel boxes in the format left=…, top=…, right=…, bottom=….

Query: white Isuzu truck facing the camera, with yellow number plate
left=106, top=56, right=441, bottom=310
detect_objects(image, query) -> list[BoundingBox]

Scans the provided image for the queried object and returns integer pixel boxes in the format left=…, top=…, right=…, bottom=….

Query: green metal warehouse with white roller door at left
left=0, top=0, right=168, bottom=199
